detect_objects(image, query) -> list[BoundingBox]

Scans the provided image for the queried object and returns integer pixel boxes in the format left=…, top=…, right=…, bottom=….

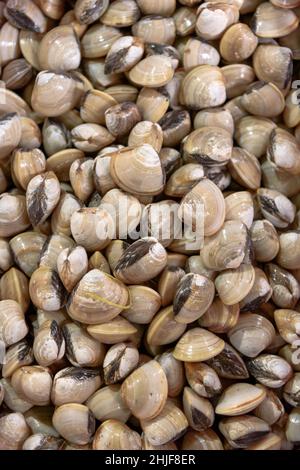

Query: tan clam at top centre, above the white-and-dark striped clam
left=131, top=13, right=176, bottom=44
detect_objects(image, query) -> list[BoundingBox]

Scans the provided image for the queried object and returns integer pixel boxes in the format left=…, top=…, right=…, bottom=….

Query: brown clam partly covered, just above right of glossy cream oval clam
left=198, top=300, right=240, bottom=333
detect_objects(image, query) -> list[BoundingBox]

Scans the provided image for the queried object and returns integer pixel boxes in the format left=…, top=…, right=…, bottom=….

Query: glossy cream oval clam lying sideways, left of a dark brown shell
left=173, top=328, right=225, bottom=362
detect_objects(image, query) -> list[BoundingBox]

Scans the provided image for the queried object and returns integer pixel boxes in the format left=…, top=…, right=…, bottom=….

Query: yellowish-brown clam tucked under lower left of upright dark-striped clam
left=147, top=306, right=186, bottom=346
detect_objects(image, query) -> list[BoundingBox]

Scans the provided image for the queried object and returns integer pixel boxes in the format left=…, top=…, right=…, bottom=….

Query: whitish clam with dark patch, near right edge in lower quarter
left=247, top=354, right=292, bottom=388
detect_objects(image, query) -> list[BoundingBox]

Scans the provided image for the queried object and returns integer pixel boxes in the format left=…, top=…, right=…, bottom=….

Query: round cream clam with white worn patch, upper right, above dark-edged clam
left=180, top=65, right=226, bottom=110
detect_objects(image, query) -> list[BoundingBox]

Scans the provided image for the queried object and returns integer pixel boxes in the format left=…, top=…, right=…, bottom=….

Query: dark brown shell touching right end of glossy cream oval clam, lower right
left=206, top=344, right=249, bottom=379
